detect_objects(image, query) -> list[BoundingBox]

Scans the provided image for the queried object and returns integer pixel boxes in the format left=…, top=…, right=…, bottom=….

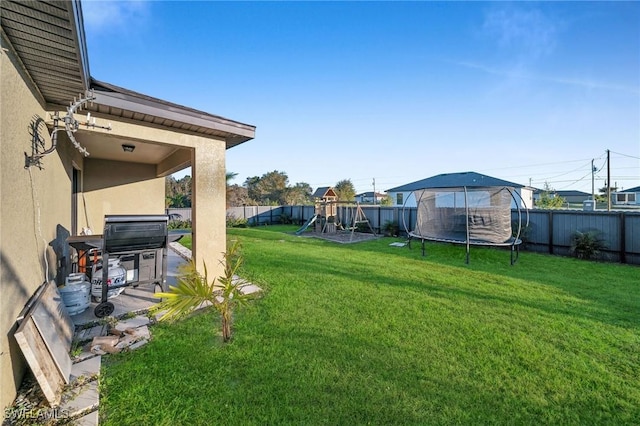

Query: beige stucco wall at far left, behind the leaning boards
left=0, top=45, right=73, bottom=407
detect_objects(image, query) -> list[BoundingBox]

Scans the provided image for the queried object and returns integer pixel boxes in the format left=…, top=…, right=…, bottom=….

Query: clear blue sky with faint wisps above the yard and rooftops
left=82, top=0, right=640, bottom=192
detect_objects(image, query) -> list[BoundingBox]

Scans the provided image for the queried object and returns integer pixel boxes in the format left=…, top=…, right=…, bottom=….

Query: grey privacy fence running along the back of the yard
left=227, top=205, right=640, bottom=265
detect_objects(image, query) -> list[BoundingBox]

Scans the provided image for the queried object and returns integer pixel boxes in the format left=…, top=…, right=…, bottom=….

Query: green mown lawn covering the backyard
left=100, top=226, right=640, bottom=425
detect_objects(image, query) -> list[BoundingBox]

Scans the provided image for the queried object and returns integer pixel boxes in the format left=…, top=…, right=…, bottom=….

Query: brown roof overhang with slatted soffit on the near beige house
left=0, top=0, right=255, bottom=149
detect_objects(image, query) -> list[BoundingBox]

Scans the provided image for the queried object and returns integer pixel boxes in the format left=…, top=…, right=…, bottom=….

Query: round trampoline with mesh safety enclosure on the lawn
left=402, top=186, right=529, bottom=265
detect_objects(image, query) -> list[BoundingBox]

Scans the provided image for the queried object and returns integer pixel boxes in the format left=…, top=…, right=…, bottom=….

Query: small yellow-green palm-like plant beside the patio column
left=152, top=241, right=251, bottom=342
